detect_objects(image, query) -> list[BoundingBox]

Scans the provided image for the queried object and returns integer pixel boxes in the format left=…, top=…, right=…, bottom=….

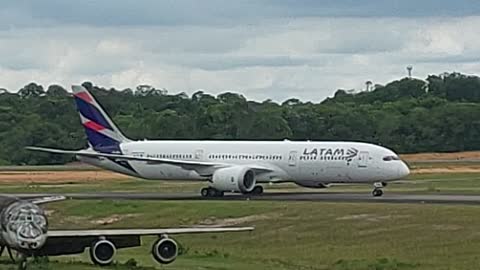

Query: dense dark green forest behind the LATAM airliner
left=0, top=73, right=480, bottom=165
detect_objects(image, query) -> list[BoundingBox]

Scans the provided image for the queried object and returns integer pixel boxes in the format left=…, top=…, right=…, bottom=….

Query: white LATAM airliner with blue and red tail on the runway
left=27, top=86, right=410, bottom=197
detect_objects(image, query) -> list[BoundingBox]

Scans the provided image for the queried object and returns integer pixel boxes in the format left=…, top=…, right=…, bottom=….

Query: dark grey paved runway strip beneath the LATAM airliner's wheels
left=12, top=192, right=480, bottom=204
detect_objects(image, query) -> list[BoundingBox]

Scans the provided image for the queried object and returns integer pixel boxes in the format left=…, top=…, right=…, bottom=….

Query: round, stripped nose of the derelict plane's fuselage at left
left=0, top=201, right=48, bottom=253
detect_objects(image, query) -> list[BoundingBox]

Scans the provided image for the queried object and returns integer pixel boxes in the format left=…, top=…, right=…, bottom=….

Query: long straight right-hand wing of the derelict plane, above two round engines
left=48, top=227, right=254, bottom=238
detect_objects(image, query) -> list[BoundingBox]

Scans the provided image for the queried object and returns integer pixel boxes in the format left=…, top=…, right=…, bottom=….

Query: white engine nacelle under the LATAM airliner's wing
left=211, top=166, right=256, bottom=193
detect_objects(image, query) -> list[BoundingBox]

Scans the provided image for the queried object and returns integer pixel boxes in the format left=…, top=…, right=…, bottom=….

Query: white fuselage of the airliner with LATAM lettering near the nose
left=80, top=141, right=409, bottom=187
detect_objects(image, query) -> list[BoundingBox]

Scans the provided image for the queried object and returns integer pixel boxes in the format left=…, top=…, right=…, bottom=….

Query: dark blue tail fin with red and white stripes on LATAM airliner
left=72, top=85, right=130, bottom=153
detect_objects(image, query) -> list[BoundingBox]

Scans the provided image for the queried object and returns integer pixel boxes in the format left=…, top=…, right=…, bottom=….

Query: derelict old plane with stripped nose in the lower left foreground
left=0, top=195, right=254, bottom=270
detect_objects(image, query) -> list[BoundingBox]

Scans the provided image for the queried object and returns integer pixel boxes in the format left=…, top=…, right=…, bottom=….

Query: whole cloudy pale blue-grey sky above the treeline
left=0, top=0, right=480, bottom=102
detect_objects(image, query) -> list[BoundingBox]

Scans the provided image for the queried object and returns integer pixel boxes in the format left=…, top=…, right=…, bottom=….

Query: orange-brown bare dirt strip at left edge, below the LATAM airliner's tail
left=0, top=171, right=129, bottom=183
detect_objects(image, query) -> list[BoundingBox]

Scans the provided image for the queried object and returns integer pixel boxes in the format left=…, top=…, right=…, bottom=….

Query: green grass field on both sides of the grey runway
left=0, top=163, right=480, bottom=270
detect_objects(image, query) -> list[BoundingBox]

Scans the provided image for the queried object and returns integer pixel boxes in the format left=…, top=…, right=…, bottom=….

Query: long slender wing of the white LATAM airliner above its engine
left=26, top=146, right=273, bottom=173
